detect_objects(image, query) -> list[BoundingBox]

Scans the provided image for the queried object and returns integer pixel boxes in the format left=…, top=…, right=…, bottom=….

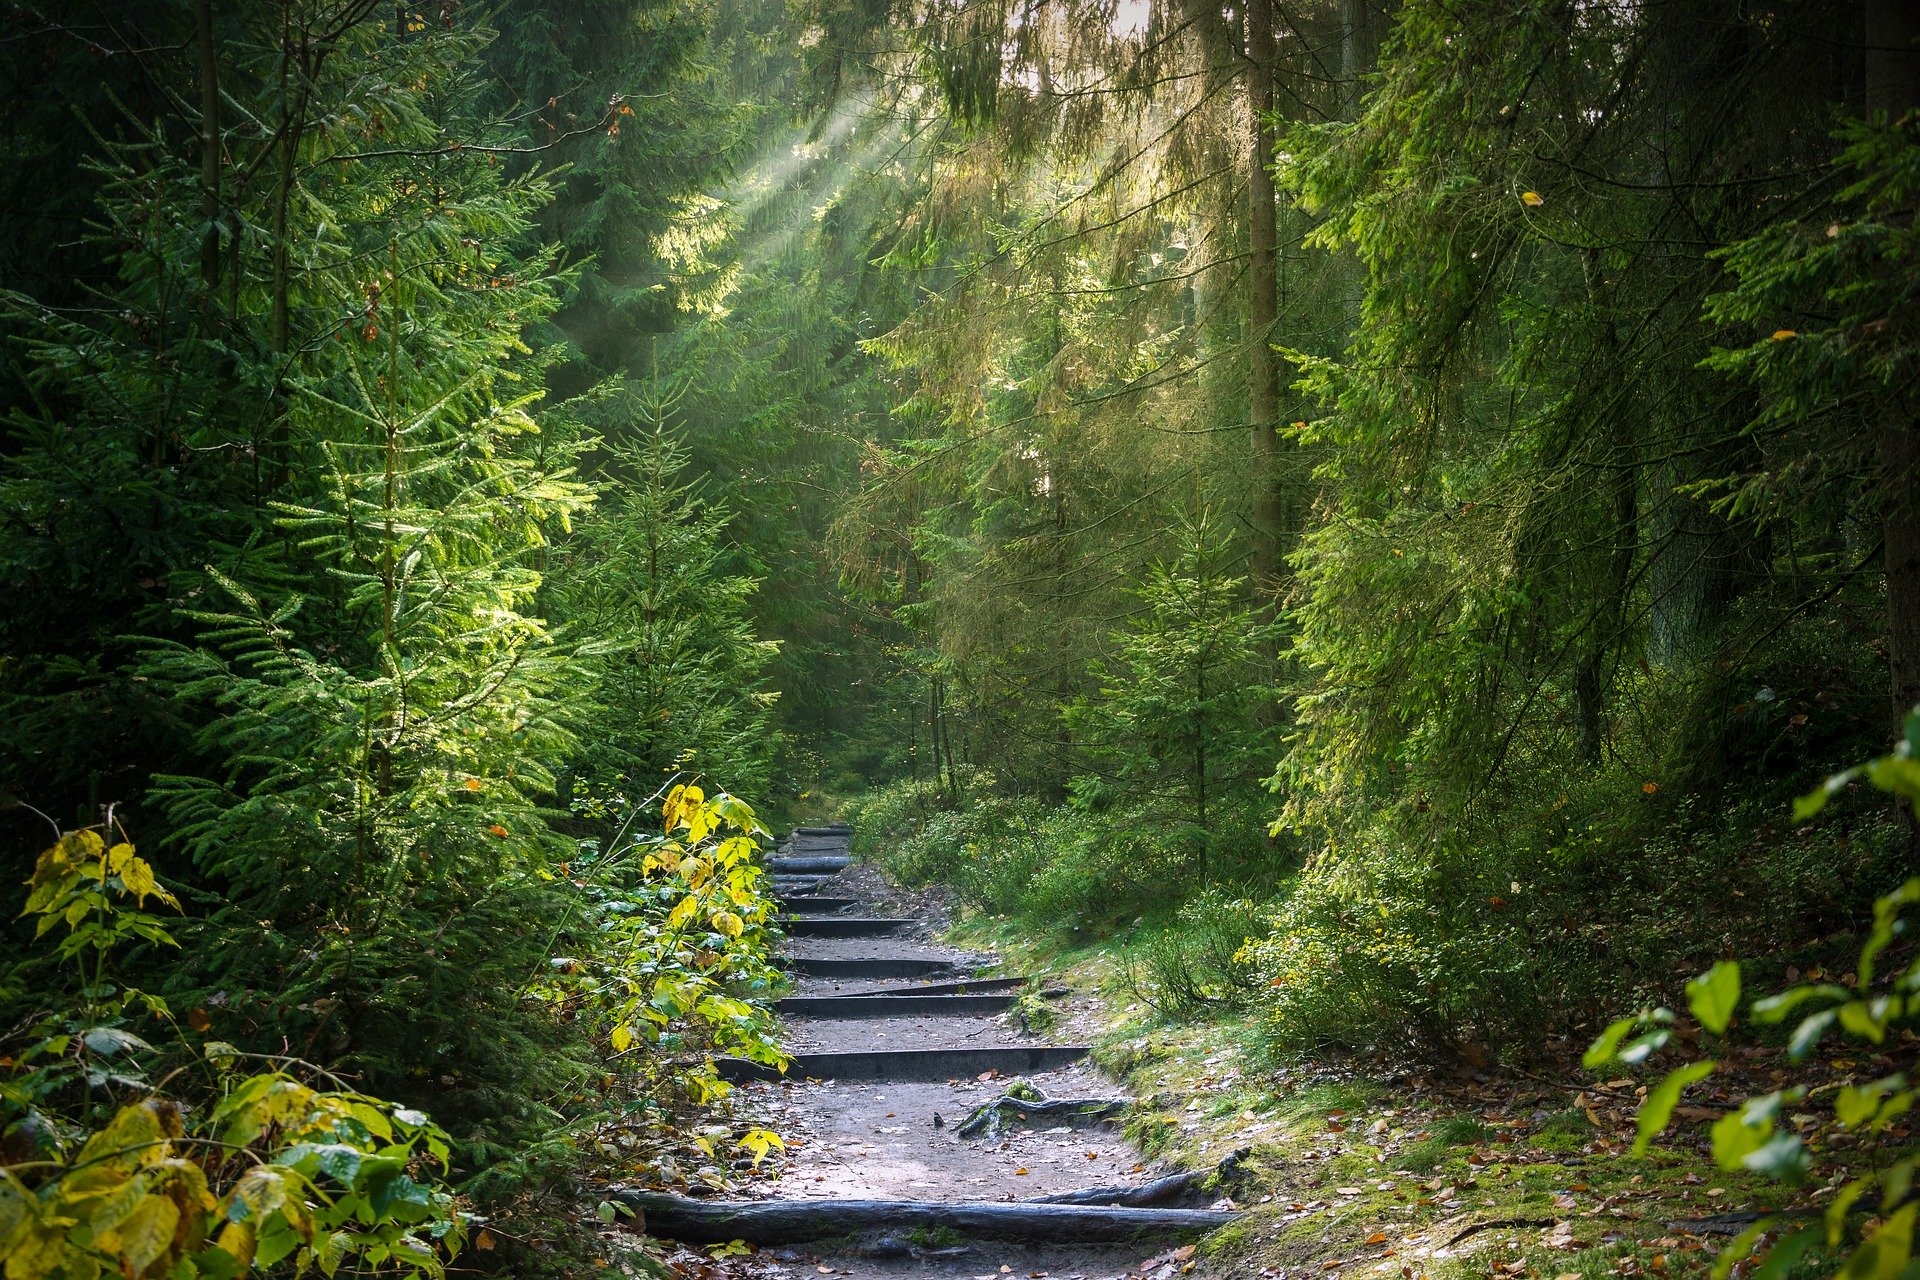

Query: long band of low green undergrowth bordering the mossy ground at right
left=854, top=744, right=1905, bottom=1065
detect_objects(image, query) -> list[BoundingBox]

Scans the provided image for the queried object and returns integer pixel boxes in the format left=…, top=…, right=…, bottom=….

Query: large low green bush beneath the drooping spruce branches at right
left=1248, top=652, right=1905, bottom=1059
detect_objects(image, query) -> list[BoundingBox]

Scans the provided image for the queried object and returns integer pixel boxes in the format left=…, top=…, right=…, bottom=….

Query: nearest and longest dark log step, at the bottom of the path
left=609, top=1190, right=1238, bottom=1245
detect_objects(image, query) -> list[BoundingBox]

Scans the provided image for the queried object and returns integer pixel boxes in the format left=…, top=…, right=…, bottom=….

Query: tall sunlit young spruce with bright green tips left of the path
left=114, top=12, right=591, bottom=1121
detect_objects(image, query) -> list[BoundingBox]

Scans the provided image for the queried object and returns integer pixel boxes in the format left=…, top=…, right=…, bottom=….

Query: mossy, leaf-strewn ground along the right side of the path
left=954, top=921, right=1820, bottom=1280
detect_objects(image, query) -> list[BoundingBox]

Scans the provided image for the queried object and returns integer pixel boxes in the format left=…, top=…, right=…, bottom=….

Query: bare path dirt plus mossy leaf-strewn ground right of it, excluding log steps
left=614, top=855, right=1827, bottom=1280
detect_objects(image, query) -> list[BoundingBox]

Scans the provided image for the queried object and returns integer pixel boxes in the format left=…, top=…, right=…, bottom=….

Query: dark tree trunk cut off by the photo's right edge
left=1864, top=0, right=1920, bottom=731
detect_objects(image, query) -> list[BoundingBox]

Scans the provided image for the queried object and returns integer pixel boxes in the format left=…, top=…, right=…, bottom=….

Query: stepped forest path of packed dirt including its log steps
left=634, top=827, right=1231, bottom=1280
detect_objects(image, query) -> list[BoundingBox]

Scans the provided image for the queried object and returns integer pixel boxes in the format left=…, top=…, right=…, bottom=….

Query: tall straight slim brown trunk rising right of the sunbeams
left=1246, top=0, right=1286, bottom=593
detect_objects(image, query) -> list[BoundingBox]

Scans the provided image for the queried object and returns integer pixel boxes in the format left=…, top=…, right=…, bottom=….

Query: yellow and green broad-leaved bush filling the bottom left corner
left=0, top=829, right=467, bottom=1280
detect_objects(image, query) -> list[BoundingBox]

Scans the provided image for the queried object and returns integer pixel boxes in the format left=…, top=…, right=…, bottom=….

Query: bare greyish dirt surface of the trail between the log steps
left=629, top=831, right=1228, bottom=1280
